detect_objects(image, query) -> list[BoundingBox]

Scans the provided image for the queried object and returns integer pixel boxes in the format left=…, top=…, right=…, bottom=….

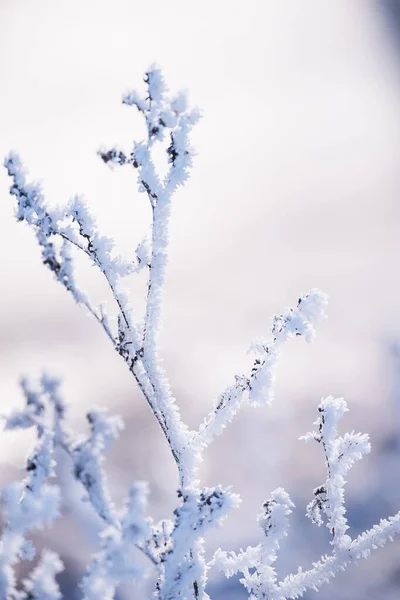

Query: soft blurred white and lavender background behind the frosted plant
left=0, top=0, right=400, bottom=600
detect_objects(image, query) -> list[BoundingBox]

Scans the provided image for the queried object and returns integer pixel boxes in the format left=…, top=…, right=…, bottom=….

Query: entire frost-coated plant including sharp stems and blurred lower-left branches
left=0, top=66, right=400, bottom=600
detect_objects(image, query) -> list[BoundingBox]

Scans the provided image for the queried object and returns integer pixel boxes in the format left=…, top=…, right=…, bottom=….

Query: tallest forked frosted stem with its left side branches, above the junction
left=5, top=66, right=199, bottom=488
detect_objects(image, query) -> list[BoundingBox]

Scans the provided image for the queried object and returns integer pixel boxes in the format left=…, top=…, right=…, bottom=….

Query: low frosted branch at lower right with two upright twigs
left=210, top=396, right=400, bottom=600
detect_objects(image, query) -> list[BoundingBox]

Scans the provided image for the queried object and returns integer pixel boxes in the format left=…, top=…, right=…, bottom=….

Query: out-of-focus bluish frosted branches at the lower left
left=0, top=375, right=154, bottom=600
